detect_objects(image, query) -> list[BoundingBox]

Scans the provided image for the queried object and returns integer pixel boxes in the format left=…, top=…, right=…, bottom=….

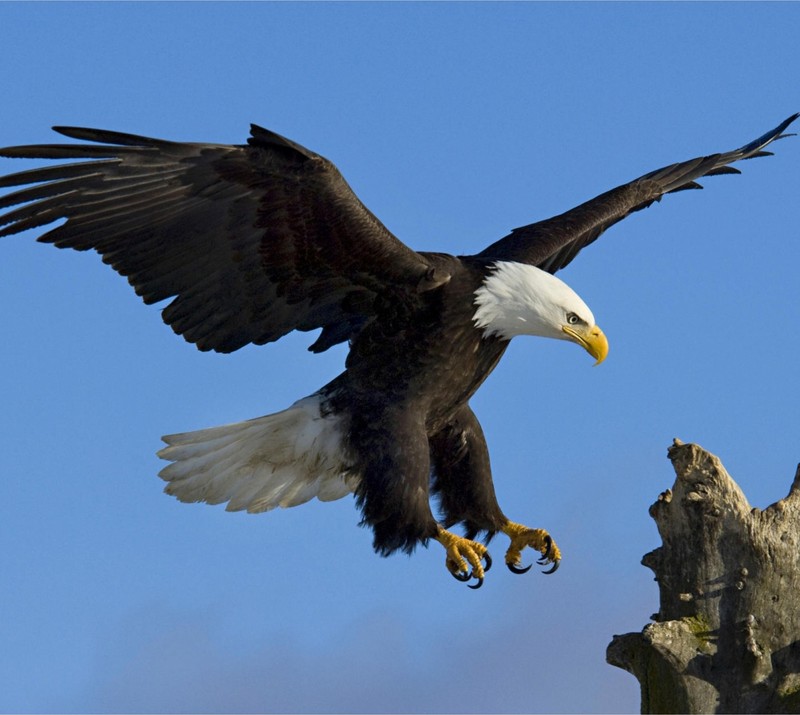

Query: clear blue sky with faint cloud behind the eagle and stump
left=0, top=3, right=800, bottom=712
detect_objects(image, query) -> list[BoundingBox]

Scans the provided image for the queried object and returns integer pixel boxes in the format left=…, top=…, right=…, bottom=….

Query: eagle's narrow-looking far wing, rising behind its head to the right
left=478, top=114, right=800, bottom=273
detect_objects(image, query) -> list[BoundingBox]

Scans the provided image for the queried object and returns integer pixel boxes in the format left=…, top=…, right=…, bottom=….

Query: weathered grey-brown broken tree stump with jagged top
left=606, top=440, right=800, bottom=713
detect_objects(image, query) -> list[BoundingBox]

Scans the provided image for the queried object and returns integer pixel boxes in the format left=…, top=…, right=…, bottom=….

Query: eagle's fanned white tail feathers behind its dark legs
left=158, top=394, right=359, bottom=513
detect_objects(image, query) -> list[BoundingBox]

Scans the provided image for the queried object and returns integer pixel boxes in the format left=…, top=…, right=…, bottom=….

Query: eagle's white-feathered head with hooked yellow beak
left=472, top=261, right=608, bottom=365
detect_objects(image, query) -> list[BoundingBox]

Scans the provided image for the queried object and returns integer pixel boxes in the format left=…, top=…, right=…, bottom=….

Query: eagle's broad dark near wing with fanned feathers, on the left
left=0, top=125, right=448, bottom=352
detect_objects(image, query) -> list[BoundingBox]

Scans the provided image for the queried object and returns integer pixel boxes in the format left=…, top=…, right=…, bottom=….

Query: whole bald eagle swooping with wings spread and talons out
left=0, top=114, right=798, bottom=588
